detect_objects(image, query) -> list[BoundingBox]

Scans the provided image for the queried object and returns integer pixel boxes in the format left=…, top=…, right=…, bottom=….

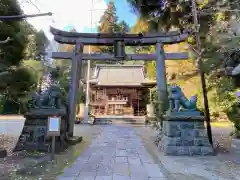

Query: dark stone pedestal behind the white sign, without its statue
left=14, top=109, right=67, bottom=152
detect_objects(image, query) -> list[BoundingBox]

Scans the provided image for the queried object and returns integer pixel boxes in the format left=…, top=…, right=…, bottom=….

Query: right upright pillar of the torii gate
left=156, top=42, right=168, bottom=114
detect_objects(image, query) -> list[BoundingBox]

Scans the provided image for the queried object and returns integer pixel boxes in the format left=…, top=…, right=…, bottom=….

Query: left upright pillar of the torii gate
left=68, top=44, right=83, bottom=137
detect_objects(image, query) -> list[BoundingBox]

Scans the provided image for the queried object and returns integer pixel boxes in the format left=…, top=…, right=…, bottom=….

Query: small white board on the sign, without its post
left=48, top=117, right=61, bottom=136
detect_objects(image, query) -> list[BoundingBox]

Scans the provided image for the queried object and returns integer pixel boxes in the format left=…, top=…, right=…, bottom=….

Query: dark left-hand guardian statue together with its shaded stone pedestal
left=14, top=85, right=68, bottom=152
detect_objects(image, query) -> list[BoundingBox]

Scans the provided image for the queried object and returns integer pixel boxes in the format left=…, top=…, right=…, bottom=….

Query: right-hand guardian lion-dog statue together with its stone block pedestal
left=158, top=86, right=213, bottom=156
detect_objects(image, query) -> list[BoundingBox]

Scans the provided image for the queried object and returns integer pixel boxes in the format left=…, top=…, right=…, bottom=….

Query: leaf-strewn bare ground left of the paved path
left=0, top=124, right=102, bottom=180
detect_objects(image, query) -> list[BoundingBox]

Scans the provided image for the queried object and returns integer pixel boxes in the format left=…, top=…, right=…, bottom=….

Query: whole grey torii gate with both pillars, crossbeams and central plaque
left=50, top=27, right=188, bottom=136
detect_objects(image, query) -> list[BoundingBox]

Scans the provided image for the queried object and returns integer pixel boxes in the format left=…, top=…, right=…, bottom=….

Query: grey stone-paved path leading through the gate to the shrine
left=57, top=125, right=166, bottom=180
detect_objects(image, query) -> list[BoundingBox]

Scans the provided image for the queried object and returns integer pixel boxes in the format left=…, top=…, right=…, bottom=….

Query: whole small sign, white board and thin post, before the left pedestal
left=47, top=116, right=61, bottom=160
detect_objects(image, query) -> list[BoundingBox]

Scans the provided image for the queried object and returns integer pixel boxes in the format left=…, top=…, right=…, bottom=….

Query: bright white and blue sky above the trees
left=22, top=0, right=136, bottom=39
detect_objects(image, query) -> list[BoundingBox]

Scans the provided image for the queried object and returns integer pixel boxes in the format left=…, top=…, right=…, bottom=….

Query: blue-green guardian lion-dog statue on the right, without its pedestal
left=168, top=86, right=198, bottom=112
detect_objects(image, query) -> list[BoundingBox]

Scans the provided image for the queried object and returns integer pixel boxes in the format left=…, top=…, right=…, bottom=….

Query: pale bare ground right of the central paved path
left=135, top=126, right=240, bottom=180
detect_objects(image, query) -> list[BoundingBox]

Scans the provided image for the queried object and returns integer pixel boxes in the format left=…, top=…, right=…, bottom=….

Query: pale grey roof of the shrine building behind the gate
left=89, top=65, right=156, bottom=87
